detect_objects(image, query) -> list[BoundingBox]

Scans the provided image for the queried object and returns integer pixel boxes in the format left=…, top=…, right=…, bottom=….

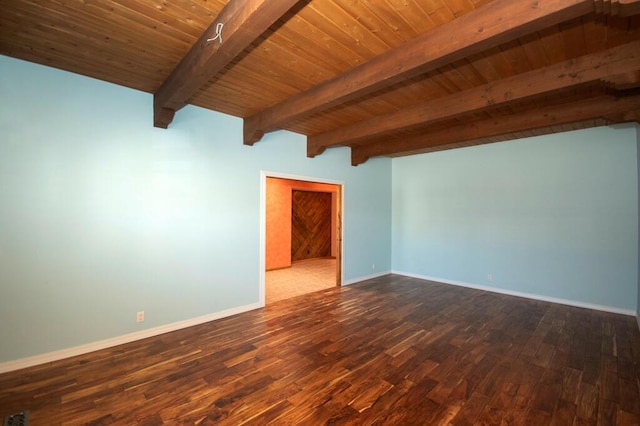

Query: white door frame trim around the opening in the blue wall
left=259, top=170, right=345, bottom=306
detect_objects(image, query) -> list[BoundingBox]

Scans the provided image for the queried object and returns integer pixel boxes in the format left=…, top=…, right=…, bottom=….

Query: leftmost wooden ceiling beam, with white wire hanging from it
left=153, top=0, right=298, bottom=129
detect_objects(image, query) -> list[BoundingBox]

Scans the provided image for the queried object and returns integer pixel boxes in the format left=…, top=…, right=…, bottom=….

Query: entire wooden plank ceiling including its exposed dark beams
left=0, top=0, right=640, bottom=165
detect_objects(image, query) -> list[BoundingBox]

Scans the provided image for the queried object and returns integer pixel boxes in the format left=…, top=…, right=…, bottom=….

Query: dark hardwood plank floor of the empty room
left=0, top=275, right=640, bottom=426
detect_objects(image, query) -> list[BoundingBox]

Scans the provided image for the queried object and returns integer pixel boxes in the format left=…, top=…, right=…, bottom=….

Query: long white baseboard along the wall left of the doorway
left=0, top=303, right=264, bottom=374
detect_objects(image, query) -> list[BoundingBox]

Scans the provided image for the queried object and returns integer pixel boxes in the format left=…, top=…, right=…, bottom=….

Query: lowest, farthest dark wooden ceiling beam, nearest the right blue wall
left=351, top=92, right=640, bottom=166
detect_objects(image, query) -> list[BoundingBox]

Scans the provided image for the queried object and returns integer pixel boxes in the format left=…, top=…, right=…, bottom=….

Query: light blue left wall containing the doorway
left=0, top=56, right=391, bottom=362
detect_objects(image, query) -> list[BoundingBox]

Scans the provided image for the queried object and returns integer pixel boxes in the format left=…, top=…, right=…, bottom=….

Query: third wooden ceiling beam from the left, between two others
left=307, top=41, right=640, bottom=157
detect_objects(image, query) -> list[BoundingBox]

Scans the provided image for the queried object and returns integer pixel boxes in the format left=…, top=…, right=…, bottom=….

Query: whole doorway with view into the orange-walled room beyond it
left=261, top=173, right=342, bottom=304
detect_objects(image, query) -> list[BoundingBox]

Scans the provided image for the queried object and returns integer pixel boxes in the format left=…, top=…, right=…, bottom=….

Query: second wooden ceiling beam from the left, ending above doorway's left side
left=244, top=0, right=608, bottom=145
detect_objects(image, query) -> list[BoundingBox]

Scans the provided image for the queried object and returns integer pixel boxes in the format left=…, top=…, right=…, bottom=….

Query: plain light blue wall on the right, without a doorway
left=391, top=126, right=638, bottom=311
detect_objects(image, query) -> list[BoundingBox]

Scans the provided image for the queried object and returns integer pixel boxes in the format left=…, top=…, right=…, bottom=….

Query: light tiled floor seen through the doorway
left=265, top=259, right=336, bottom=304
